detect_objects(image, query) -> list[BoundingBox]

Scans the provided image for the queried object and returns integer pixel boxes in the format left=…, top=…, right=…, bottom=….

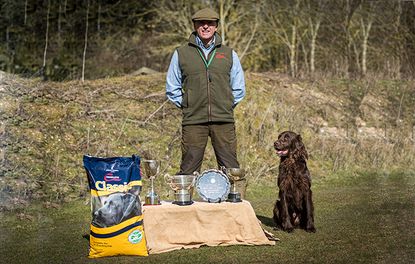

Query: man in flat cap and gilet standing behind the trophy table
left=166, top=8, right=245, bottom=174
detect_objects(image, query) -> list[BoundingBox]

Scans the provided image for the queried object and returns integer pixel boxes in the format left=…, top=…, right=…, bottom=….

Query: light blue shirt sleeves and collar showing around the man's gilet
left=166, top=37, right=245, bottom=107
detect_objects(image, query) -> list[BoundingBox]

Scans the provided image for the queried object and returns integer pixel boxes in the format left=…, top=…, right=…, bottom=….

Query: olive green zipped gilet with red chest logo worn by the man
left=177, top=32, right=234, bottom=125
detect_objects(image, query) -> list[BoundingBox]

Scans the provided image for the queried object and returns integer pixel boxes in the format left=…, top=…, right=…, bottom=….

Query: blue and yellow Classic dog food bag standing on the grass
left=83, top=155, right=148, bottom=258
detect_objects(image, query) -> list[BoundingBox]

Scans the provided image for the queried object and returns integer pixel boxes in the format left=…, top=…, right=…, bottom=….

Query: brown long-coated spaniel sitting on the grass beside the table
left=274, top=131, right=316, bottom=232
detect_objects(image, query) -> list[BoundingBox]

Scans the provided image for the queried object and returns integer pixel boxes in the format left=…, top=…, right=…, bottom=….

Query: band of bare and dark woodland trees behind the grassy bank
left=0, top=0, right=415, bottom=78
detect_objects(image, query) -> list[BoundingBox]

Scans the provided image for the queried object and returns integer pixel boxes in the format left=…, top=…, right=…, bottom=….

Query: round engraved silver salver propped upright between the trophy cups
left=196, top=169, right=231, bottom=203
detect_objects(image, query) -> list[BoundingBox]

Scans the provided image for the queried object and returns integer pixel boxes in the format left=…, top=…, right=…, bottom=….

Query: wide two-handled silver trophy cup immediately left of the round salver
left=164, top=175, right=196, bottom=205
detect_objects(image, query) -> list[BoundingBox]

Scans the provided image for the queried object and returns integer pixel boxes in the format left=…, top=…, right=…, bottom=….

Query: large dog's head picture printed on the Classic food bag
left=92, top=192, right=141, bottom=227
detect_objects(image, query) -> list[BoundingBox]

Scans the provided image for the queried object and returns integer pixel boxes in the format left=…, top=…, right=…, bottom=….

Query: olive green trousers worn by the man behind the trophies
left=179, top=123, right=239, bottom=174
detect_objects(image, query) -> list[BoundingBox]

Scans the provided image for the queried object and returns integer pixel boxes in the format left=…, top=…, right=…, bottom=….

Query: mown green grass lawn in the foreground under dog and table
left=0, top=170, right=415, bottom=263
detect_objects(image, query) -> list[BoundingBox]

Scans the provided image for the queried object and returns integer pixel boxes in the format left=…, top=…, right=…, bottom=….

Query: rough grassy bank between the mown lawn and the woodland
left=0, top=73, right=415, bottom=206
